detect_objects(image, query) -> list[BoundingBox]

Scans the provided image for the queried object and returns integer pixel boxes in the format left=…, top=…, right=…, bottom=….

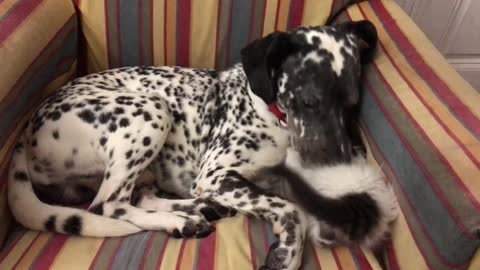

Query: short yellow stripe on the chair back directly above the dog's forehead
left=302, top=0, right=333, bottom=26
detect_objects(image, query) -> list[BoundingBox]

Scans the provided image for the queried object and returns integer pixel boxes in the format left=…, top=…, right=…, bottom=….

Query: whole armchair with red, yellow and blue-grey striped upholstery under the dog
left=0, top=0, right=480, bottom=270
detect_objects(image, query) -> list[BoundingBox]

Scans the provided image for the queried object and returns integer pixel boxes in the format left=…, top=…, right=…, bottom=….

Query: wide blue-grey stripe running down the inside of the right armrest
left=361, top=87, right=480, bottom=264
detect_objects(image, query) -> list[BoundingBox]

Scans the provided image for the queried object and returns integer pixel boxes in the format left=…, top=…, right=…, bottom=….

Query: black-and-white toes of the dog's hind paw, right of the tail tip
left=170, top=217, right=215, bottom=238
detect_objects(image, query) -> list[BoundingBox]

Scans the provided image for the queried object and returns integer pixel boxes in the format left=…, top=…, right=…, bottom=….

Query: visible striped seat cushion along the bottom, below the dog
left=0, top=215, right=381, bottom=270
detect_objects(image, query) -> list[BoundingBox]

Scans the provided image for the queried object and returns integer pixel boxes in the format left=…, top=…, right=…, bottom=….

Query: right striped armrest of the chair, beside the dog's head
left=349, top=0, right=480, bottom=269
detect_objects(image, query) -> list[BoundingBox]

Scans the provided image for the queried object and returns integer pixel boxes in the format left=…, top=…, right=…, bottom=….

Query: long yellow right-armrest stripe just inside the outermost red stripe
left=350, top=5, right=480, bottom=165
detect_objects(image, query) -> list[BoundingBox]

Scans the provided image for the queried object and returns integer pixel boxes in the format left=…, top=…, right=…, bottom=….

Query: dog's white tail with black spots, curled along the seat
left=8, top=138, right=141, bottom=237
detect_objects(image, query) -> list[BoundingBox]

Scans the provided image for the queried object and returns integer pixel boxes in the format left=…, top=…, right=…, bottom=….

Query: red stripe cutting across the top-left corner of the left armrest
left=0, top=0, right=42, bottom=43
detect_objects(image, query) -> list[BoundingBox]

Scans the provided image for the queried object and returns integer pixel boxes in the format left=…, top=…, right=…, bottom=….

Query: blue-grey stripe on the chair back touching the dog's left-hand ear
left=228, top=0, right=252, bottom=66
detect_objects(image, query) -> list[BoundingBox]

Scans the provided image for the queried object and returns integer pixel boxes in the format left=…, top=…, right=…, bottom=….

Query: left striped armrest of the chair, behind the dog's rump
left=0, top=0, right=77, bottom=247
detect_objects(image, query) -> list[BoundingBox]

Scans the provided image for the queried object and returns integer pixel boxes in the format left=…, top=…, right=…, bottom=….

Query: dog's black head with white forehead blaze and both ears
left=242, top=21, right=377, bottom=164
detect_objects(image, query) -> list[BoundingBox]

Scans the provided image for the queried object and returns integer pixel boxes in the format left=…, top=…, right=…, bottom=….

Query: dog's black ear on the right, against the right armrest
left=337, top=20, right=378, bottom=64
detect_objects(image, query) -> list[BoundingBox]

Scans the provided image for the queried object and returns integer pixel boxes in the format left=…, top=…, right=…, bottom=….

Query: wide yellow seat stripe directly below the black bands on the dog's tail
left=51, top=237, right=104, bottom=270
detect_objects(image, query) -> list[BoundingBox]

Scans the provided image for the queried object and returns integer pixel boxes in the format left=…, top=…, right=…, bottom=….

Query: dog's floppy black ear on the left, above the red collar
left=241, top=32, right=293, bottom=104
